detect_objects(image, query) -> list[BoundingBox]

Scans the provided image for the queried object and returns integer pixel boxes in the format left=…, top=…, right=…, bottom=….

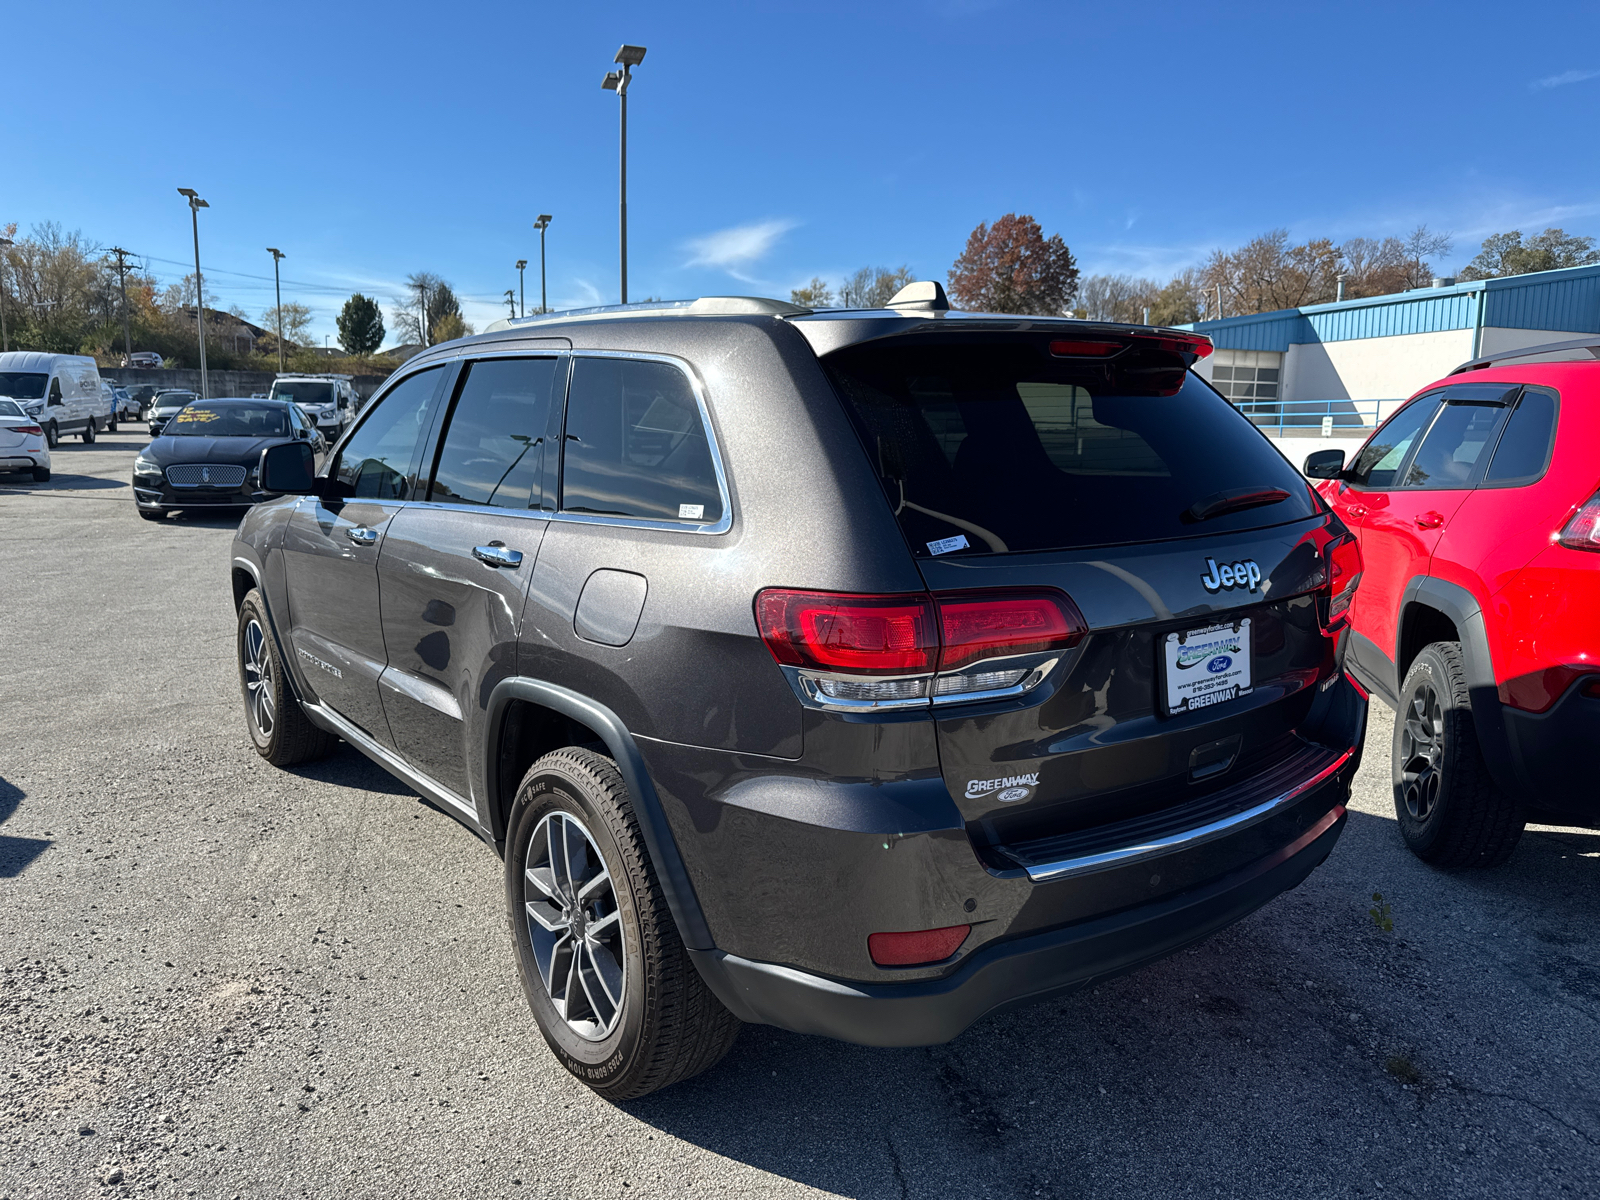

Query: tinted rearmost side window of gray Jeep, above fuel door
left=562, top=358, right=722, bottom=523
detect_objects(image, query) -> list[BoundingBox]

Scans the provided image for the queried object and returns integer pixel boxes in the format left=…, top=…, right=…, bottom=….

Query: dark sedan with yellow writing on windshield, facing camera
left=133, top=398, right=328, bottom=522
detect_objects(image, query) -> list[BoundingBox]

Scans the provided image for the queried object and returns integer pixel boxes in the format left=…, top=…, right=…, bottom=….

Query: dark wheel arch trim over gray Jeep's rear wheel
left=483, top=677, right=715, bottom=950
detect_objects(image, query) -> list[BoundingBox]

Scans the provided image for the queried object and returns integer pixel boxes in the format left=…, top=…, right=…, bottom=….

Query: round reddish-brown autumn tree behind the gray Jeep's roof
left=949, top=213, right=1078, bottom=317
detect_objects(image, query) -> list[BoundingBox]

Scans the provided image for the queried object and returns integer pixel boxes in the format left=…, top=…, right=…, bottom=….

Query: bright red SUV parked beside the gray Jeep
left=1306, top=341, right=1600, bottom=867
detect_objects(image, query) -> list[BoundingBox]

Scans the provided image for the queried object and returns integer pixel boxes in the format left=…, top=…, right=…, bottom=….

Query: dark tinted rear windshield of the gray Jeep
left=827, top=339, right=1318, bottom=555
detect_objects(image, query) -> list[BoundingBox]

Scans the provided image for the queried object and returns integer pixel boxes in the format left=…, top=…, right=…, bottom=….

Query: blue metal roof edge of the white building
left=1184, top=266, right=1600, bottom=352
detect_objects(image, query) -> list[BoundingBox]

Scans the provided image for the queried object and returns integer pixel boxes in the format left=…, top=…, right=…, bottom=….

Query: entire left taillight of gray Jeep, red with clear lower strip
left=755, top=587, right=1088, bottom=706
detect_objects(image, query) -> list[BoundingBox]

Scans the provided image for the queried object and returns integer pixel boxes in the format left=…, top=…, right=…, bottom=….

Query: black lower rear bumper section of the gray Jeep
left=690, top=803, right=1347, bottom=1046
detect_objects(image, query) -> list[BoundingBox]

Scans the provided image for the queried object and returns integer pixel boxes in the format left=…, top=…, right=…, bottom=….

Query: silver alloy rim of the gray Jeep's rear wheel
left=523, top=811, right=627, bottom=1042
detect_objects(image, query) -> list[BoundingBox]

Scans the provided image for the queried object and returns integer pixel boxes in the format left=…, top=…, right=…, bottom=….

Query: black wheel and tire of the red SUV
left=1390, top=642, right=1526, bottom=867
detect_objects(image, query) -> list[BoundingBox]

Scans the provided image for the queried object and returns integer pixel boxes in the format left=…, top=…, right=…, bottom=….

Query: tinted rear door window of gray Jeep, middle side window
left=429, top=358, right=558, bottom=509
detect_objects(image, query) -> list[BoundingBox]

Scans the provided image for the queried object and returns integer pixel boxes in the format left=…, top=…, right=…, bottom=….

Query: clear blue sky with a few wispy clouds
left=0, top=0, right=1600, bottom=347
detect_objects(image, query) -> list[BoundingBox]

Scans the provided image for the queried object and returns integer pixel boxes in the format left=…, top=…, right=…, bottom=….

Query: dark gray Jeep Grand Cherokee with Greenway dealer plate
left=232, top=283, right=1366, bottom=1099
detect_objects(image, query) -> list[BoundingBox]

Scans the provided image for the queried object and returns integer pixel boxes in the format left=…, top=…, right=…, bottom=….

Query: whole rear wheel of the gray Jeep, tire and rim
left=506, top=746, right=742, bottom=1101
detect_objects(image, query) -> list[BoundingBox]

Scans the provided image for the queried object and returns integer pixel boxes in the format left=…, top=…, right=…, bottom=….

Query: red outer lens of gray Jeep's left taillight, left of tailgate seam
left=755, top=587, right=939, bottom=675
